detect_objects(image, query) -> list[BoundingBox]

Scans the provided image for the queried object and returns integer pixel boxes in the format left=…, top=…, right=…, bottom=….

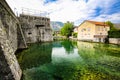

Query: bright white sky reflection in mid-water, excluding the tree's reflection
left=52, top=47, right=81, bottom=65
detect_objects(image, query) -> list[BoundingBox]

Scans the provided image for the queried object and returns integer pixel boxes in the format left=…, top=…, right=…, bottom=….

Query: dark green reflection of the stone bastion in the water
left=18, top=43, right=52, bottom=69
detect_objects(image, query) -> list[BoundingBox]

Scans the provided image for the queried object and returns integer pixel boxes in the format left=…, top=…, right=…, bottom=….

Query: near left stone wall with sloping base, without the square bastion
left=0, top=0, right=27, bottom=80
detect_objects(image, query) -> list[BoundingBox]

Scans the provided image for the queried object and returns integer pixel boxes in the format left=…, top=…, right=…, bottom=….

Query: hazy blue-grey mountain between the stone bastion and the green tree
left=50, top=21, right=64, bottom=31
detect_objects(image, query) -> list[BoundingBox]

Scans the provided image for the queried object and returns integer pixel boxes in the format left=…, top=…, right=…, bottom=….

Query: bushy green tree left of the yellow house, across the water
left=60, top=22, right=73, bottom=37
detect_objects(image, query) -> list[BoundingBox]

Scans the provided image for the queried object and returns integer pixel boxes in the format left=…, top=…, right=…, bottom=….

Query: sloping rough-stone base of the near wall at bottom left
left=0, top=20, right=22, bottom=80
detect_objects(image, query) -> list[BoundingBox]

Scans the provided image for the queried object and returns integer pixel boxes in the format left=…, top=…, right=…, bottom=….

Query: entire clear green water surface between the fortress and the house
left=17, top=40, right=120, bottom=80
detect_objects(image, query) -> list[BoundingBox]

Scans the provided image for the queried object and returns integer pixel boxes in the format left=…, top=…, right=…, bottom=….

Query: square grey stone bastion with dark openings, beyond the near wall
left=19, top=14, right=53, bottom=43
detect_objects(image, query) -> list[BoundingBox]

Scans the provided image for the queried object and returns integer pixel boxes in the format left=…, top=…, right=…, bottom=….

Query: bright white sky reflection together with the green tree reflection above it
left=52, top=40, right=82, bottom=65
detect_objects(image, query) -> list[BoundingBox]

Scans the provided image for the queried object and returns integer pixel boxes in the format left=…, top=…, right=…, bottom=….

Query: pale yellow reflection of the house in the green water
left=77, top=41, right=95, bottom=57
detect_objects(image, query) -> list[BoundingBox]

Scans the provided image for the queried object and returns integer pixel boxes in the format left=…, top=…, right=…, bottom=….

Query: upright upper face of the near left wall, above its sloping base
left=0, top=0, right=17, bottom=51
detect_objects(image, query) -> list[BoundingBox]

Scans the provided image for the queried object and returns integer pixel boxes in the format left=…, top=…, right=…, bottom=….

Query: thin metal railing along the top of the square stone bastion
left=22, top=8, right=49, bottom=17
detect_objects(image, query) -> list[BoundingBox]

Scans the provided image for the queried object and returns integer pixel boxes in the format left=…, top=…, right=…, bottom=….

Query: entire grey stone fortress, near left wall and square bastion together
left=0, top=0, right=52, bottom=80
